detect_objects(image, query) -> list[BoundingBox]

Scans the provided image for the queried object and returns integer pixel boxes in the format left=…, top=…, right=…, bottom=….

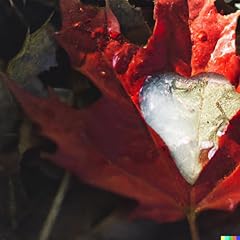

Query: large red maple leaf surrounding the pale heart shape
left=3, top=0, right=240, bottom=222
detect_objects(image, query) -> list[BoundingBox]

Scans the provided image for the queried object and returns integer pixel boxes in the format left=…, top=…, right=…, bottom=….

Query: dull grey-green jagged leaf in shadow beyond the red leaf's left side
left=7, top=21, right=57, bottom=96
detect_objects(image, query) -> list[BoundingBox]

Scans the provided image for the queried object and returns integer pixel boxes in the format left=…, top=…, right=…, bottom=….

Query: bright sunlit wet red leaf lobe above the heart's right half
left=189, top=0, right=240, bottom=86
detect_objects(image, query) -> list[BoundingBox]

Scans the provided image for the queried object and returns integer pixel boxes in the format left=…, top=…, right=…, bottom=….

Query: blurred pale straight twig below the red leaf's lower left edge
left=39, top=172, right=70, bottom=240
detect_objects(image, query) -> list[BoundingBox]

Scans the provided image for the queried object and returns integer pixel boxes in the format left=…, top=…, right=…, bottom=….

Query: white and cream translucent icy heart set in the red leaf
left=140, top=73, right=240, bottom=184
